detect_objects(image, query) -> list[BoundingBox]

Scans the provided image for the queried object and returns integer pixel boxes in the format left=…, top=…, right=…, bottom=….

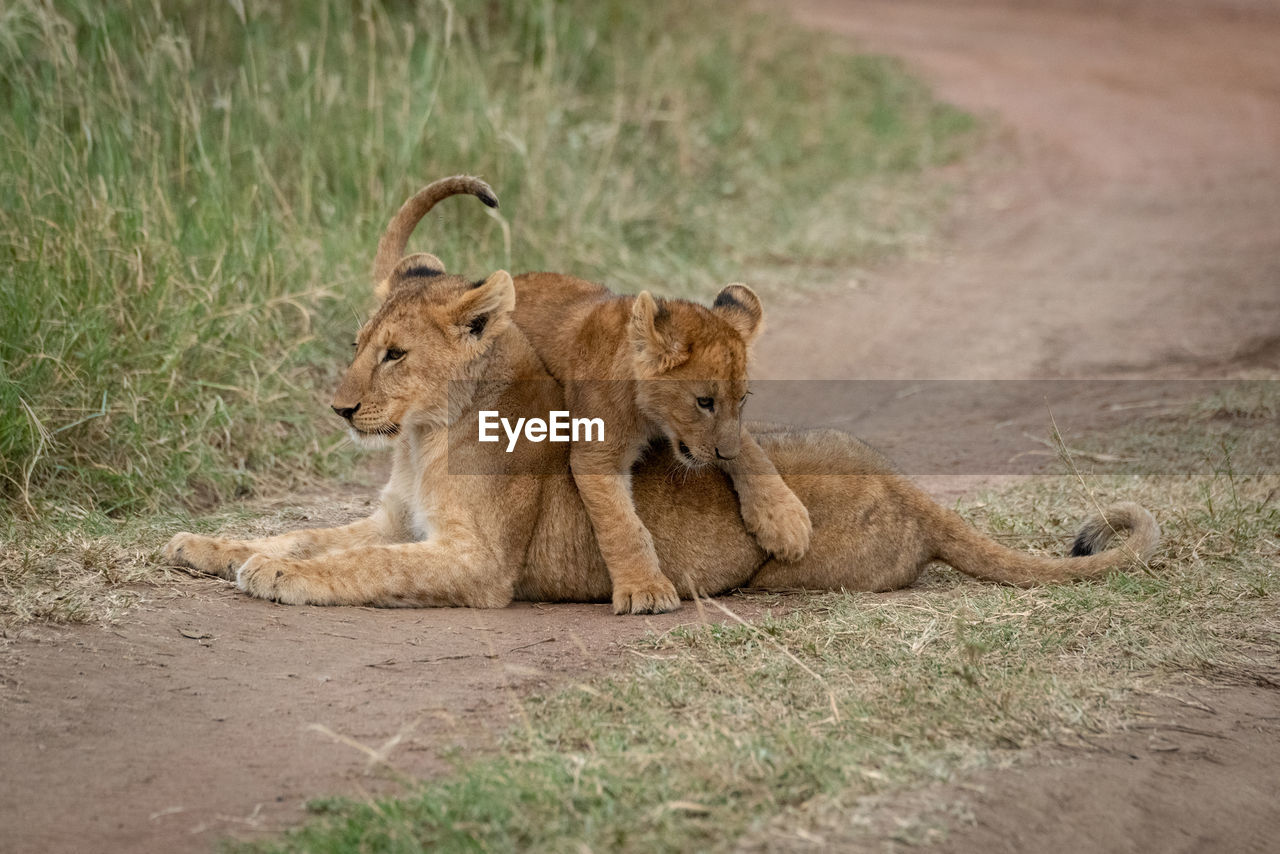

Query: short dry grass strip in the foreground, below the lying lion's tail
left=235, top=406, right=1280, bottom=853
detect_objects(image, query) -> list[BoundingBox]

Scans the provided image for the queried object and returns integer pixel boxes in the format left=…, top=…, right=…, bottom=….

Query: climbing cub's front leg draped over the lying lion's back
left=721, top=430, right=813, bottom=561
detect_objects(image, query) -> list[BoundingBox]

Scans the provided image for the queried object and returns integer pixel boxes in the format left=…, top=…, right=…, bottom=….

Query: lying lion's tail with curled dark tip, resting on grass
left=933, top=502, right=1160, bottom=586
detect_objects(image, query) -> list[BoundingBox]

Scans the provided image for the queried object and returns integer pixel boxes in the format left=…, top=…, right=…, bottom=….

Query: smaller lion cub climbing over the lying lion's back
left=515, top=273, right=812, bottom=613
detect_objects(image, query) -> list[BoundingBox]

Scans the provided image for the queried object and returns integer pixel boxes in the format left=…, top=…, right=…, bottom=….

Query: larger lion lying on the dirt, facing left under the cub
left=165, top=176, right=1160, bottom=608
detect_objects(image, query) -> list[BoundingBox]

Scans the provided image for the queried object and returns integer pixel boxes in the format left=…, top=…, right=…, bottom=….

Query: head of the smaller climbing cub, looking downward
left=630, top=284, right=764, bottom=467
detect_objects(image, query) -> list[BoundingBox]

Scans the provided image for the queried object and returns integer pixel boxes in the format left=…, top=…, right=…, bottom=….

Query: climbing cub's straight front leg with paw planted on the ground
left=573, top=448, right=680, bottom=613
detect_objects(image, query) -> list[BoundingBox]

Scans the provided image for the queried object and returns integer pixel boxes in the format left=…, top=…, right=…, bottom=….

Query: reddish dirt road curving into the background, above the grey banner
left=760, top=0, right=1280, bottom=379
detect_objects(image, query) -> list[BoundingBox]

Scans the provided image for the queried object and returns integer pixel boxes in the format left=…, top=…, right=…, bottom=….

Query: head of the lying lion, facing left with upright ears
left=333, top=254, right=516, bottom=444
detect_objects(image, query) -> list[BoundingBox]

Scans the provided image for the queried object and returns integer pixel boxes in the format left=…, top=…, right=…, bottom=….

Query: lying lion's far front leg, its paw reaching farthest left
left=161, top=516, right=387, bottom=581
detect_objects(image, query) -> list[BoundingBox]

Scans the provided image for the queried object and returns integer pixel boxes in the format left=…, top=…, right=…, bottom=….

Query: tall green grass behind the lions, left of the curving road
left=0, top=0, right=970, bottom=524
